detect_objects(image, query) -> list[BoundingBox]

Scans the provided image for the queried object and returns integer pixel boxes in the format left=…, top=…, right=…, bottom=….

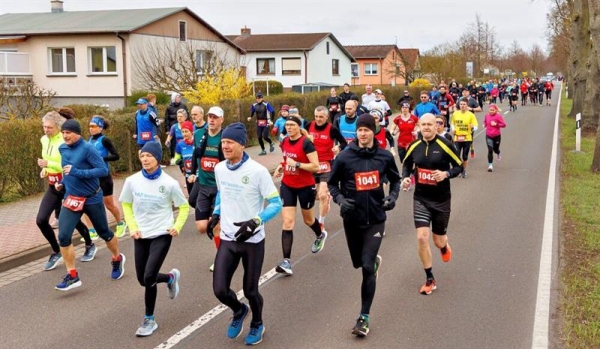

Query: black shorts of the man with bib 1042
left=413, top=198, right=450, bottom=235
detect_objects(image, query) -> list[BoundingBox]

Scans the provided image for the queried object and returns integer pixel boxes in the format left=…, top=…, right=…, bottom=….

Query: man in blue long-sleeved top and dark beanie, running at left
left=55, top=120, right=125, bottom=291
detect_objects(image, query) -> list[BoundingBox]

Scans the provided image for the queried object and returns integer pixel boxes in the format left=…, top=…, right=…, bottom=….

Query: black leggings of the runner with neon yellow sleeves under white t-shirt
left=133, top=234, right=173, bottom=316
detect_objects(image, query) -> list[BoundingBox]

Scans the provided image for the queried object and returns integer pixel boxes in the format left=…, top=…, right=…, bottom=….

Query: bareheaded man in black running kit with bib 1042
left=402, top=113, right=464, bottom=295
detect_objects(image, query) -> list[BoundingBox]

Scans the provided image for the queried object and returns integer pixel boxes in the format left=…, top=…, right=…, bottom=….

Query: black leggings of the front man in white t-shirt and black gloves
left=213, top=240, right=265, bottom=325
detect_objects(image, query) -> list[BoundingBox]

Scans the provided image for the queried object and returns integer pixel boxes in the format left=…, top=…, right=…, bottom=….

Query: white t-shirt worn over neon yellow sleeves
left=119, top=171, right=187, bottom=239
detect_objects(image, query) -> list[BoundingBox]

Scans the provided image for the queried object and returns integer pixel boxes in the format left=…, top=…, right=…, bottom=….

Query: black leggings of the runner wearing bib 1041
left=344, top=220, right=385, bottom=314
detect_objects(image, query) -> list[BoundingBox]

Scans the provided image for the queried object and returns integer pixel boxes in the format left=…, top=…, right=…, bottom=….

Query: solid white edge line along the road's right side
left=531, top=85, right=562, bottom=349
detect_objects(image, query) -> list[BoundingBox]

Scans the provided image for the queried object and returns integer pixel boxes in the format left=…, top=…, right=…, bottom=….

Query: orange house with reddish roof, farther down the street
left=344, top=45, right=421, bottom=86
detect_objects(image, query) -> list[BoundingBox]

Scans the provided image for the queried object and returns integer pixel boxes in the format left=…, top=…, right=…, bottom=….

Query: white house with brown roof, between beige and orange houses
left=227, top=28, right=354, bottom=88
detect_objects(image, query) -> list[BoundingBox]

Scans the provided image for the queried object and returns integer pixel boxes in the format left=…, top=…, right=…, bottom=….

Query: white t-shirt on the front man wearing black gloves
left=215, top=159, right=278, bottom=243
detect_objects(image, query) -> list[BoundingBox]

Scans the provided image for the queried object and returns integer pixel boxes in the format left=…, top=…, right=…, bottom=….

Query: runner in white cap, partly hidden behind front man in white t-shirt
left=189, top=106, right=225, bottom=271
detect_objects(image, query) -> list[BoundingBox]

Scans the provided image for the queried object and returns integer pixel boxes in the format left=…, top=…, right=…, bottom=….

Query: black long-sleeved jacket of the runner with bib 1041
left=327, top=140, right=400, bottom=226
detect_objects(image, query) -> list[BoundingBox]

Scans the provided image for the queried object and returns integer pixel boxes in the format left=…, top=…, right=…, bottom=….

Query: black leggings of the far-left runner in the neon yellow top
left=35, top=186, right=92, bottom=253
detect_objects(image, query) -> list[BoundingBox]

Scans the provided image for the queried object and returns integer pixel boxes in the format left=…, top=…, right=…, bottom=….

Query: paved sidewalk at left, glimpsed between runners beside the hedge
left=0, top=145, right=282, bottom=272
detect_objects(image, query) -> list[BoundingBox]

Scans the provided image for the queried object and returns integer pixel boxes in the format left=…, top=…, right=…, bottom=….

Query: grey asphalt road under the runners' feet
left=0, top=95, right=556, bottom=349
